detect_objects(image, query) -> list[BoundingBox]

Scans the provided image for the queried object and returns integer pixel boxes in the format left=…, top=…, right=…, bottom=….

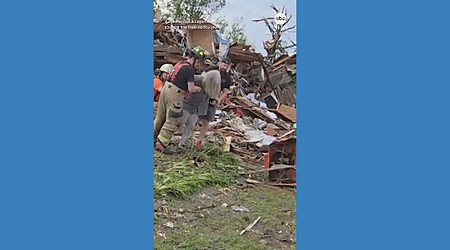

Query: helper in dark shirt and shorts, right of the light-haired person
left=197, top=57, right=232, bottom=149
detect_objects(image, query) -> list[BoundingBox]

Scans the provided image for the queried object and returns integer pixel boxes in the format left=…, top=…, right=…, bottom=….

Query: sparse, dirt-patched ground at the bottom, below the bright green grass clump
left=155, top=185, right=296, bottom=250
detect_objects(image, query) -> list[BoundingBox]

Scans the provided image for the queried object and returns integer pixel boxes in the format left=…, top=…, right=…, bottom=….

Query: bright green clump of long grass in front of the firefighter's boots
left=154, top=145, right=240, bottom=198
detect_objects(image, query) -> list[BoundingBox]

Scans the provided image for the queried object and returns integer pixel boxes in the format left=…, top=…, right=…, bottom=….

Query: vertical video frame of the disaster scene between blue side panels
left=153, top=0, right=297, bottom=250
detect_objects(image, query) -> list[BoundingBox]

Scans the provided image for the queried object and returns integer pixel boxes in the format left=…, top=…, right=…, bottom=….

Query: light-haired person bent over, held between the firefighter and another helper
left=178, top=59, right=221, bottom=149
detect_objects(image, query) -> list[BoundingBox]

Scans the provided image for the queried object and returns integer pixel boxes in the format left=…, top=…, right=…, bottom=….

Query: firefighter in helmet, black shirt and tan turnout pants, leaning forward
left=153, top=47, right=208, bottom=153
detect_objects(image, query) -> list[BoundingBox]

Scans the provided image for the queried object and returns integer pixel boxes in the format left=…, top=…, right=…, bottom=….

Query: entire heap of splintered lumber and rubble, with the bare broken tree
left=154, top=6, right=296, bottom=185
